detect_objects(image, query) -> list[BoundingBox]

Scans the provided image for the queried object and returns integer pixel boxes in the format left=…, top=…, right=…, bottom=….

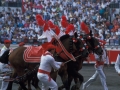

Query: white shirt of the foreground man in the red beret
left=39, top=51, right=62, bottom=72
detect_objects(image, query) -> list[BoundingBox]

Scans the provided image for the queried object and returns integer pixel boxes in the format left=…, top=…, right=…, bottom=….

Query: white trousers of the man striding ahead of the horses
left=84, top=65, right=108, bottom=90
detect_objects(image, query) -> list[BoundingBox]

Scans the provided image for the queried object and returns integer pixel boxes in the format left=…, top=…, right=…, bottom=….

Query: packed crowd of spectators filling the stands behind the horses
left=0, top=0, right=120, bottom=45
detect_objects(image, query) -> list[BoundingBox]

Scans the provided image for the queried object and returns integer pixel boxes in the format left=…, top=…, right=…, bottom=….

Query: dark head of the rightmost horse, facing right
left=83, top=35, right=103, bottom=55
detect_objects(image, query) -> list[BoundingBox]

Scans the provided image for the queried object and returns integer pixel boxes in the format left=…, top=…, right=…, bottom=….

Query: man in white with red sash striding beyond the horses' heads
left=82, top=48, right=109, bottom=90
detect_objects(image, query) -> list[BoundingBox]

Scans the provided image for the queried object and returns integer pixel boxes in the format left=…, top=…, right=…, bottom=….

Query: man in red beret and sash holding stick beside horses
left=37, top=44, right=64, bottom=90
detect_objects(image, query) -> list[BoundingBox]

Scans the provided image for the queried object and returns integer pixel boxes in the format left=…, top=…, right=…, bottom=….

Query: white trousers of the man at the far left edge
left=0, top=63, right=11, bottom=90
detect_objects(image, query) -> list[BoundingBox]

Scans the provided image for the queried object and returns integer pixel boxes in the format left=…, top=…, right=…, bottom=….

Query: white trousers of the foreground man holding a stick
left=37, top=73, right=58, bottom=90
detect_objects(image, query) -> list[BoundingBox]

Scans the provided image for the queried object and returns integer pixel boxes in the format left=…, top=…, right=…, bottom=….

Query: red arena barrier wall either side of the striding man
left=84, top=50, right=120, bottom=64
